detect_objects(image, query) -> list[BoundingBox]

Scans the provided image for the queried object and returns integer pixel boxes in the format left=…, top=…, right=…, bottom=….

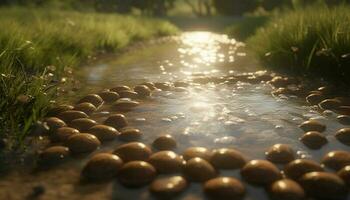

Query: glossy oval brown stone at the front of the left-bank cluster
left=66, top=133, right=101, bottom=153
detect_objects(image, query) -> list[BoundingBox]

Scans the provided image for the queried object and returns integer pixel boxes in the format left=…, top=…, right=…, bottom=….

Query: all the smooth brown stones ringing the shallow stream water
left=38, top=72, right=350, bottom=200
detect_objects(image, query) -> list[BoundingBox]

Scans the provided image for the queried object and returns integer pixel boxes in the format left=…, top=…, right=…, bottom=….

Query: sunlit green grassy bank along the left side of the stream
left=0, top=8, right=177, bottom=146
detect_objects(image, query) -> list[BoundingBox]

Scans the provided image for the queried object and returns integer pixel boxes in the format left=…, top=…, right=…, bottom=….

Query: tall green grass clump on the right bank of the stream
left=248, top=6, right=350, bottom=83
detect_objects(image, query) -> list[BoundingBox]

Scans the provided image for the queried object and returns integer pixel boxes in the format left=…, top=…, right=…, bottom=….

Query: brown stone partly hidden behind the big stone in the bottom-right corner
left=283, top=159, right=324, bottom=181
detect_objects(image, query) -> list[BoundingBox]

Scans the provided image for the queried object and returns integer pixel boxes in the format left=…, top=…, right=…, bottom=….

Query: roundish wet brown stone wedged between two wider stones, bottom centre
left=183, top=157, right=217, bottom=182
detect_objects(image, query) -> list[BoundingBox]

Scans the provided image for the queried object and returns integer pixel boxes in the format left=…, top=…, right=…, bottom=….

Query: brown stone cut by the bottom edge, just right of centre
left=204, top=177, right=246, bottom=200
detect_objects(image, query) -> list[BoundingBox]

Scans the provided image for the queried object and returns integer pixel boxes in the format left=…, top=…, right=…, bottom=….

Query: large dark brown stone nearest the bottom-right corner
left=300, top=172, right=348, bottom=200
